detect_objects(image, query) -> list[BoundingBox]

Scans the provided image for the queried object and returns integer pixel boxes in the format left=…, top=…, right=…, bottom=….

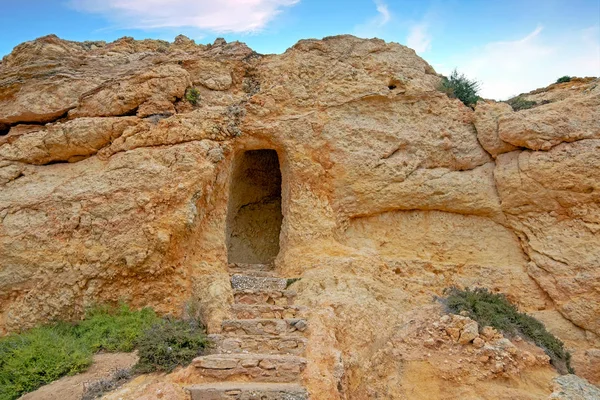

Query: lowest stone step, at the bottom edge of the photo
left=186, top=382, right=308, bottom=400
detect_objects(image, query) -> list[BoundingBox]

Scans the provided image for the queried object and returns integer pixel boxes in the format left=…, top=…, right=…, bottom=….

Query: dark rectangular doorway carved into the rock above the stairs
left=227, top=150, right=283, bottom=264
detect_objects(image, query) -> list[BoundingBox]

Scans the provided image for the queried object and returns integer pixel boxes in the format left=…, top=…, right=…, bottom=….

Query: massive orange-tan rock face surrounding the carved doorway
left=0, top=36, right=600, bottom=399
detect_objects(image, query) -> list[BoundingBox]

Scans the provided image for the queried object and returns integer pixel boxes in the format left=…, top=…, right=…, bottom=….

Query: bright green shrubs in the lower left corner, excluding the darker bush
left=0, top=305, right=160, bottom=400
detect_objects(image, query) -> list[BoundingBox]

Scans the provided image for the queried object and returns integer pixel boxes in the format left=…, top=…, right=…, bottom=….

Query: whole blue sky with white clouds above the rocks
left=0, top=0, right=600, bottom=99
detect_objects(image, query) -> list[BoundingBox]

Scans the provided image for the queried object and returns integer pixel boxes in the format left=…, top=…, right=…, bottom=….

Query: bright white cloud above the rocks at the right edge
left=439, top=26, right=600, bottom=100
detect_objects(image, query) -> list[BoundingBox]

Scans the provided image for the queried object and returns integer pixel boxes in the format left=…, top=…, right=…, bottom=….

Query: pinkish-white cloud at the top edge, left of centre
left=71, top=0, right=300, bottom=33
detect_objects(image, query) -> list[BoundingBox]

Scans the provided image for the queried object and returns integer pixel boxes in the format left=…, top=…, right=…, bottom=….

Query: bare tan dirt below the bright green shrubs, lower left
left=21, top=353, right=138, bottom=400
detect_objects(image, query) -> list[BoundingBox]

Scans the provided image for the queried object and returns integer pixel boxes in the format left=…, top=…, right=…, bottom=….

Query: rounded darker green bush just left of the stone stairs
left=135, top=318, right=208, bottom=373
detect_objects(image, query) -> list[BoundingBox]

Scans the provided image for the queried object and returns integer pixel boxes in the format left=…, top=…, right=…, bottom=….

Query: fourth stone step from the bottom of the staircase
left=221, top=318, right=307, bottom=336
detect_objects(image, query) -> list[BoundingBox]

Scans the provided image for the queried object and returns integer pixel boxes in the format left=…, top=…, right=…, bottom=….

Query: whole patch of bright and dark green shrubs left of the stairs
left=0, top=305, right=206, bottom=400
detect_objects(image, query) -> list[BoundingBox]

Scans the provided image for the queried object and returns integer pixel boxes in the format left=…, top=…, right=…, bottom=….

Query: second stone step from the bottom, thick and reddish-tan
left=192, top=354, right=306, bottom=382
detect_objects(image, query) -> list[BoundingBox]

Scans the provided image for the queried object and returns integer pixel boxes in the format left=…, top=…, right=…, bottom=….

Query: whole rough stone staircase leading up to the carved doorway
left=187, top=264, right=308, bottom=400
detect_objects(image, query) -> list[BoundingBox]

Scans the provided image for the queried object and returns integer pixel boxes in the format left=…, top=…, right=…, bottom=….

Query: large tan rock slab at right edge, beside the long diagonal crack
left=495, top=140, right=600, bottom=334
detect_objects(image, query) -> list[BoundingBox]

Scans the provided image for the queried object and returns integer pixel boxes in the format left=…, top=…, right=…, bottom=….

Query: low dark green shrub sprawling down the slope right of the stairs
left=443, top=287, right=574, bottom=373
